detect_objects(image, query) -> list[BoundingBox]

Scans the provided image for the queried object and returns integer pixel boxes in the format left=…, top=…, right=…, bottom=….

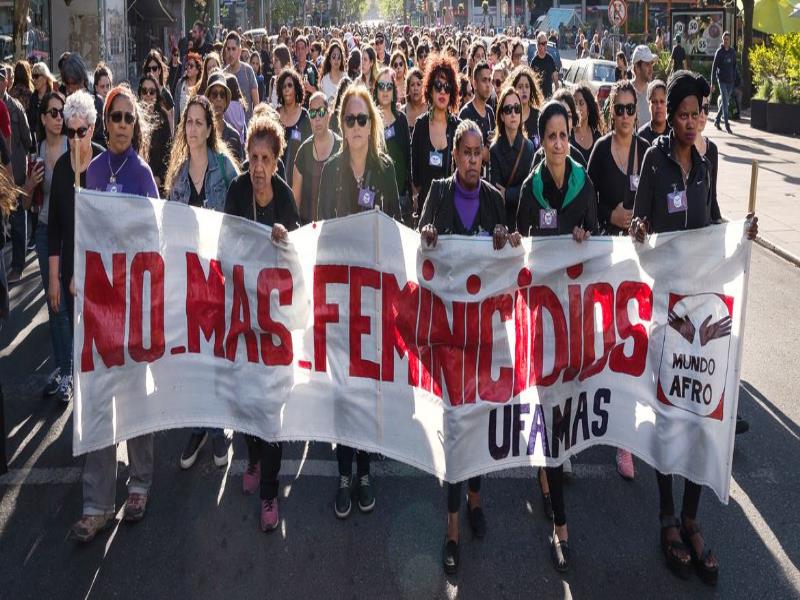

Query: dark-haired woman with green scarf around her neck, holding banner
left=516, top=101, right=597, bottom=572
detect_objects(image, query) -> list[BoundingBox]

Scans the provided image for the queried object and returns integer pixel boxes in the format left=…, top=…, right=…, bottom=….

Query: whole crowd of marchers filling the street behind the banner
left=0, top=22, right=757, bottom=583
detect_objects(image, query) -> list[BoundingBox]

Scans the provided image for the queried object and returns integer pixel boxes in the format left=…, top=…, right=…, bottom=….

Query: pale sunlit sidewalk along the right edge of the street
left=703, top=112, right=800, bottom=266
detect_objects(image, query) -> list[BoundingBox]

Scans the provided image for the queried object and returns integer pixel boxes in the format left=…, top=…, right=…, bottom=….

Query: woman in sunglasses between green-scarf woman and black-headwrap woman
left=589, top=79, right=649, bottom=236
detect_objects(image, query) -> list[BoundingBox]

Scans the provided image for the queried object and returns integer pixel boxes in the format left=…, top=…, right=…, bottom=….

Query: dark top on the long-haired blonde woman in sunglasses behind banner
left=317, top=148, right=400, bottom=221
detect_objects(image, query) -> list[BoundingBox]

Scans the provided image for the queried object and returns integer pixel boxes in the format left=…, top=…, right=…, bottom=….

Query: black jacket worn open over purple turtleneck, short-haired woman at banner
left=418, top=174, right=506, bottom=235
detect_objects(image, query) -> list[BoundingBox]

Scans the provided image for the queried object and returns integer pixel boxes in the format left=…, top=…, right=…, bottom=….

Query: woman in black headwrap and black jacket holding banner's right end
left=630, top=71, right=758, bottom=584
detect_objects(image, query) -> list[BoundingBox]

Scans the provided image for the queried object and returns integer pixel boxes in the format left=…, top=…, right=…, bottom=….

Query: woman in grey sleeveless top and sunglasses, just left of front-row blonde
left=292, top=92, right=342, bottom=225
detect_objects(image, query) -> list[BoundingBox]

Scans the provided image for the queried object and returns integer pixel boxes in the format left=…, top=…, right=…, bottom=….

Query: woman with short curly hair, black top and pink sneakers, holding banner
left=225, top=110, right=300, bottom=531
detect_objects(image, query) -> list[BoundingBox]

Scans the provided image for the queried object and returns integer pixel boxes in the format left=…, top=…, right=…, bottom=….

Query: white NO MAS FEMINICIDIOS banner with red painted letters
left=73, top=191, right=750, bottom=501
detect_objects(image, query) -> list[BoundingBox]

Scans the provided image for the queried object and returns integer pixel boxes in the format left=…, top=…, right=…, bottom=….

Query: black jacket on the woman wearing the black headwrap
left=633, top=133, right=712, bottom=233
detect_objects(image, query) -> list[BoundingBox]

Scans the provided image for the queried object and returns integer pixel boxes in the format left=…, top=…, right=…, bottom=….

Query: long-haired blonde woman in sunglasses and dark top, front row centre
left=317, top=82, right=400, bottom=519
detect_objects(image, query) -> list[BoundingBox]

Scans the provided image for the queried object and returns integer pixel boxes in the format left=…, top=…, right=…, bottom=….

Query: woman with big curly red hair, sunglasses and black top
left=411, top=56, right=459, bottom=220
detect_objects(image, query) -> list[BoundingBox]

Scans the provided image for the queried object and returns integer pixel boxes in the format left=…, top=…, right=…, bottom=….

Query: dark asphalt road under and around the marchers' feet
left=0, top=247, right=800, bottom=600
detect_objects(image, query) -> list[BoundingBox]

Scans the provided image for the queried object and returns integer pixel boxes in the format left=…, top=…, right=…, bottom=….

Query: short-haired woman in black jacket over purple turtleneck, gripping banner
left=419, top=119, right=520, bottom=575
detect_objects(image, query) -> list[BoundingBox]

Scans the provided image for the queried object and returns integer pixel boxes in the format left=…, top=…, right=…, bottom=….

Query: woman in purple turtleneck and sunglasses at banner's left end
left=71, top=84, right=158, bottom=542
